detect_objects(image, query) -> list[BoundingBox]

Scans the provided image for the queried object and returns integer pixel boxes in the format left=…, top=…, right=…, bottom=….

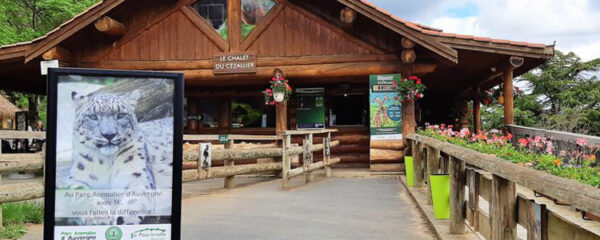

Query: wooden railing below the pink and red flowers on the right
left=406, top=134, right=600, bottom=240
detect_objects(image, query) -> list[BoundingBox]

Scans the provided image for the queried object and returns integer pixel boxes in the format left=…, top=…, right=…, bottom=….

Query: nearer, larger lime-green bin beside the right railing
left=429, top=174, right=450, bottom=219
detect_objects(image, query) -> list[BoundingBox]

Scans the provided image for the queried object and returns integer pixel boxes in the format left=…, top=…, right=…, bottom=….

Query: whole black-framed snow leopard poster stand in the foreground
left=44, top=68, right=183, bottom=240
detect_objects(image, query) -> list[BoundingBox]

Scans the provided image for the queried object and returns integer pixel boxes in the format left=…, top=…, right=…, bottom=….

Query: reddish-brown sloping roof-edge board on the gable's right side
left=337, top=0, right=458, bottom=63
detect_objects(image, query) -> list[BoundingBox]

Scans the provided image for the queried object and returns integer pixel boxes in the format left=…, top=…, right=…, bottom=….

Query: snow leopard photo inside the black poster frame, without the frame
left=55, top=75, right=174, bottom=226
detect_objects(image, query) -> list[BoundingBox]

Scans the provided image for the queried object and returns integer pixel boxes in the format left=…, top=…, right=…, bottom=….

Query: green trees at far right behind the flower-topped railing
left=482, top=51, right=600, bottom=135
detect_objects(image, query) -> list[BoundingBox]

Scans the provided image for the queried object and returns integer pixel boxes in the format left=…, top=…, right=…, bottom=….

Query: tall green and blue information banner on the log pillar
left=369, top=74, right=402, bottom=140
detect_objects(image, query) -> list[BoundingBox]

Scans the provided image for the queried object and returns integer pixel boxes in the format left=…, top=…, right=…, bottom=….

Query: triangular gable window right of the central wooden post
left=242, top=0, right=275, bottom=37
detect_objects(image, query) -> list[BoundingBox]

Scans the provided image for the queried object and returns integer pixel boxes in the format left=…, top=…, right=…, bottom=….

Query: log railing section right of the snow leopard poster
left=183, top=130, right=340, bottom=188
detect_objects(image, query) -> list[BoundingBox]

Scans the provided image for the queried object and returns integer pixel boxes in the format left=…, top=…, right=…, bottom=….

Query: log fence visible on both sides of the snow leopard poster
left=0, top=130, right=339, bottom=226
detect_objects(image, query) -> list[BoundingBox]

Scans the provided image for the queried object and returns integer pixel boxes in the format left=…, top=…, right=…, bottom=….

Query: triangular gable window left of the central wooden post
left=192, top=0, right=228, bottom=39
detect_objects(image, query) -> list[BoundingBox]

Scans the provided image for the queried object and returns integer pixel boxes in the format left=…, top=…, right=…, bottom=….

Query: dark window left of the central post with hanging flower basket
left=231, top=97, right=275, bottom=128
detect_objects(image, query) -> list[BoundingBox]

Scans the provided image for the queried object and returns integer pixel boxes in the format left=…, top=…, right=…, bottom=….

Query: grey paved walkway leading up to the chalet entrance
left=25, top=172, right=435, bottom=240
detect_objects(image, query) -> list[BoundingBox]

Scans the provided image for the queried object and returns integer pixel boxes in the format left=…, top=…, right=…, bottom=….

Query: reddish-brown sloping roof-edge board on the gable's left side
left=25, top=0, right=125, bottom=63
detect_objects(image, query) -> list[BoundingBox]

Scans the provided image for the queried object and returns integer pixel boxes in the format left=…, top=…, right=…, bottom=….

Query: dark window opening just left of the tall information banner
left=329, top=94, right=368, bottom=126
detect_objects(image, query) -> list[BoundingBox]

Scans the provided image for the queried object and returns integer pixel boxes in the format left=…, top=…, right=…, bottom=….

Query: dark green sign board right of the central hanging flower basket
left=296, top=88, right=325, bottom=128
